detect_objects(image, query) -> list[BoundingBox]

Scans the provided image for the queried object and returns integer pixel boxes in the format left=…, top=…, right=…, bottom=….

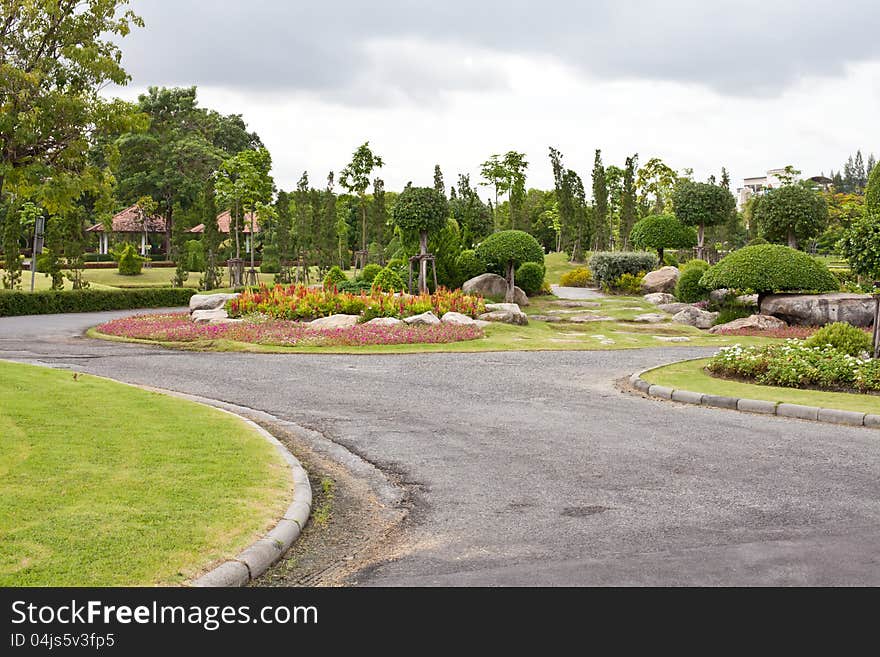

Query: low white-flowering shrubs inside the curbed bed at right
left=708, top=340, right=880, bottom=392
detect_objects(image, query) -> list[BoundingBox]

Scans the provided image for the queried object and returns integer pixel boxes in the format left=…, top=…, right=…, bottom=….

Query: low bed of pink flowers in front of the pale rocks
left=97, top=313, right=483, bottom=347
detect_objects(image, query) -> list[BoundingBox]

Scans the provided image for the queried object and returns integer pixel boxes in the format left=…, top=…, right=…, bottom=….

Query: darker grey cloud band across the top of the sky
left=123, top=0, right=880, bottom=104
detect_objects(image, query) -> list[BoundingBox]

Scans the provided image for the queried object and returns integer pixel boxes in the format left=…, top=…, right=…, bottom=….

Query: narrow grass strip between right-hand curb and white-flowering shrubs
left=642, top=359, right=880, bottom=414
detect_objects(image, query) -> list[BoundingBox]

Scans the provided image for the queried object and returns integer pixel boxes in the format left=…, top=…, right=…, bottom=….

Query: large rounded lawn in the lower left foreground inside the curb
left=0, top=361, right=292, bottom=586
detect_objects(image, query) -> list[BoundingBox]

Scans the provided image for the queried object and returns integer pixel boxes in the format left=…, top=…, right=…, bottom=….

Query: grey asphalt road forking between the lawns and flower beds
left=0, top=313, right=880, bottom=585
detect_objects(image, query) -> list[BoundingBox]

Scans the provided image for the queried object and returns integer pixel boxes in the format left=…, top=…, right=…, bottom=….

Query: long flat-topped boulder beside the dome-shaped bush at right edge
left=761, top=292, right=874, bottom=327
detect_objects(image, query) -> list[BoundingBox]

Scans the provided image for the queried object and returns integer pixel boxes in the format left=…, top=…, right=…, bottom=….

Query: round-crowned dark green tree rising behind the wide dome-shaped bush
left=754, top=185, right=828, bottom=249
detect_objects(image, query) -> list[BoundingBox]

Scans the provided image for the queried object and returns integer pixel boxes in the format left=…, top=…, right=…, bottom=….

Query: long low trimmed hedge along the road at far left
left=0, top=287, right=196, bottom=317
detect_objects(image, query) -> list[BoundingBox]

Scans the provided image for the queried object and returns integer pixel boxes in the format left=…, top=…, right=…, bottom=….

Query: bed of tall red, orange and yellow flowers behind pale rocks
left=226, top=285, right=486, bottom=322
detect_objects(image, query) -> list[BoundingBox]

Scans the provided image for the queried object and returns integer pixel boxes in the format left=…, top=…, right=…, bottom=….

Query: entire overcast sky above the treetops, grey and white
left=108, top=0, right=880, bottom=197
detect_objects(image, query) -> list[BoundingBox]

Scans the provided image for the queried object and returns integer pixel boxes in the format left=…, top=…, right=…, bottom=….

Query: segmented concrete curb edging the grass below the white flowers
left=629, top=366, right=880, bottom=429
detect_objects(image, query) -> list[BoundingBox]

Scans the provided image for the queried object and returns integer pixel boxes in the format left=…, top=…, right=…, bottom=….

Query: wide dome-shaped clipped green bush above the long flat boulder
left=700, top=244, right=840, bottom=294
